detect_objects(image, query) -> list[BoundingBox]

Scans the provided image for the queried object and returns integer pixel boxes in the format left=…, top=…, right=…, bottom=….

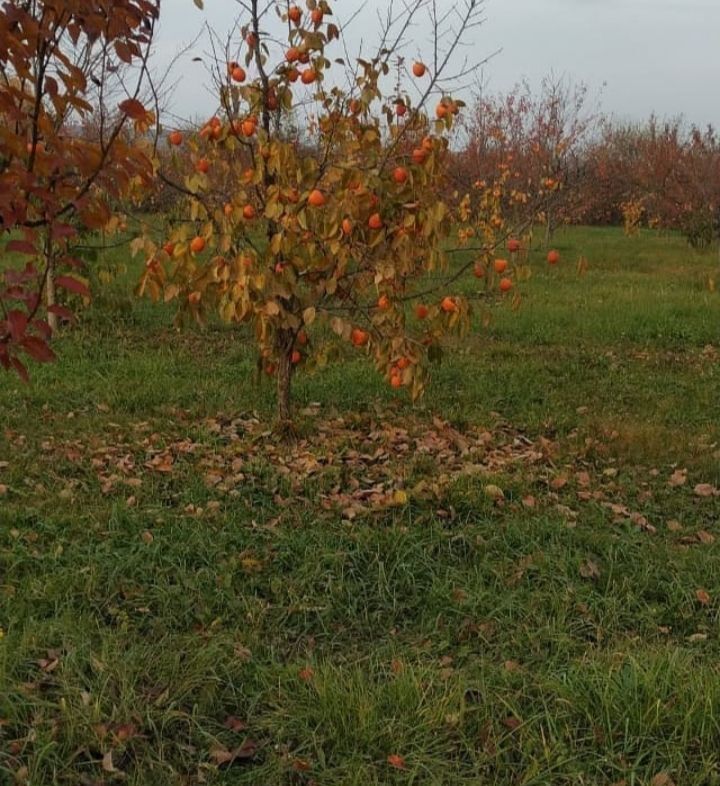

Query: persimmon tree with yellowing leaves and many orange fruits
left=135, top=0, right=536, bottom=421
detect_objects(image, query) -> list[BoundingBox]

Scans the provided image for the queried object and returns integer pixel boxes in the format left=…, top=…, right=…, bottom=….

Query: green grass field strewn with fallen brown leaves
left=0, top=224, right=720, bottom=786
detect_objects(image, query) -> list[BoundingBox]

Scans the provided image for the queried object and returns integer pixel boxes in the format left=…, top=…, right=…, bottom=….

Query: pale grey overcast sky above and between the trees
left=158, top=0, right=720, bottom=126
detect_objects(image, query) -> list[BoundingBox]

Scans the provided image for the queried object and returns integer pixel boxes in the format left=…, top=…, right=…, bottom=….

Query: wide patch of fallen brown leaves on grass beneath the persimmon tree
left=2, top=406, right=720, bottom=537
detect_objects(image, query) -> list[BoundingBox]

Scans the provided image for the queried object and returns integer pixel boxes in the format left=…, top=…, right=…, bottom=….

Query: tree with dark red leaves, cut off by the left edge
left=0, top=0, right=160, bottom=378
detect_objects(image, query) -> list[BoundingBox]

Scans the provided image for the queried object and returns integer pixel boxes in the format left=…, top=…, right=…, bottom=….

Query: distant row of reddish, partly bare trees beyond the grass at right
left=450, top=78, right=720, bottom=247
